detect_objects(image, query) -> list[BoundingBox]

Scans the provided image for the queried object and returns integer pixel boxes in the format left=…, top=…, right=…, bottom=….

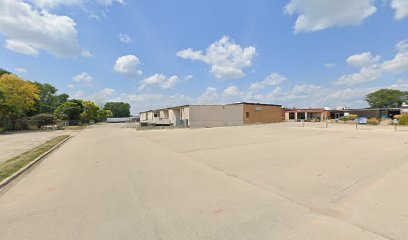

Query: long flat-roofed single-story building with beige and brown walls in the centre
left=140, top=102, right=284, bottom=127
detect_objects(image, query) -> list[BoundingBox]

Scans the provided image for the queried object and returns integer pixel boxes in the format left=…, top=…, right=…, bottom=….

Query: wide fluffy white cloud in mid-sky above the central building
left=177, top=36, right=256, bottom=79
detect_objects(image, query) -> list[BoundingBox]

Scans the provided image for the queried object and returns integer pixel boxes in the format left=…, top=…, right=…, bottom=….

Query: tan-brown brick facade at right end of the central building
left=243, top=104, right=285, bottom=124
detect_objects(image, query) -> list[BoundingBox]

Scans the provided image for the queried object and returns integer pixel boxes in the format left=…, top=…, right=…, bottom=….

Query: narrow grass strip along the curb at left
left=0, top=135, right=69, bottom=182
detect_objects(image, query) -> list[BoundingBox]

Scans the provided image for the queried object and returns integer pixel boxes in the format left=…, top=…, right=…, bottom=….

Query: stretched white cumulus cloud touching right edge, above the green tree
left=335, top=40, right=408, bottom=86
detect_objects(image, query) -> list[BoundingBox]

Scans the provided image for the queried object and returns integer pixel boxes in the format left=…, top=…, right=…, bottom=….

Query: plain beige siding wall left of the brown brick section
left=190, top=105, right=244, bottom=127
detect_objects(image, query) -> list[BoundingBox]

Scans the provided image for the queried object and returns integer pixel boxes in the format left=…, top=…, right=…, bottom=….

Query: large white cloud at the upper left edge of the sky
left=0, top=0, right=81, bottom=57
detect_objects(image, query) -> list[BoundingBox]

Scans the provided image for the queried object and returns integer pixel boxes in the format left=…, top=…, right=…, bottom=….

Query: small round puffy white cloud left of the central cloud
left=113, top=55, right=143, bottom=78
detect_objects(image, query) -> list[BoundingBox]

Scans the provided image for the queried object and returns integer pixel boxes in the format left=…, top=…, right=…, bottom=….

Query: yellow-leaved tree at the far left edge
left=0, top=74, right=40, bottom=119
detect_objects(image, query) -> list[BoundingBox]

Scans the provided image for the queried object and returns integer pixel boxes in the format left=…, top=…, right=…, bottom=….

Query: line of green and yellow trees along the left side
left=0, top=69, right=130, bottom=131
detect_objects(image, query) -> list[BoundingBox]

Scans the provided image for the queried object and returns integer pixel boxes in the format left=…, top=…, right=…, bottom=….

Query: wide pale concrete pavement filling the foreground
left=0, top=125, right=408, bottom=240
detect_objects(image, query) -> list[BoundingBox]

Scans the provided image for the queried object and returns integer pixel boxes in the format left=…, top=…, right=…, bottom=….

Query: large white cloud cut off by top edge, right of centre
left=285, top=0, right=377, bottom=33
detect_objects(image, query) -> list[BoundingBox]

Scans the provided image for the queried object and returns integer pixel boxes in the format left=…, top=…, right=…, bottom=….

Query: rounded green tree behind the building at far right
left=365, top=89, right=408, bottom=108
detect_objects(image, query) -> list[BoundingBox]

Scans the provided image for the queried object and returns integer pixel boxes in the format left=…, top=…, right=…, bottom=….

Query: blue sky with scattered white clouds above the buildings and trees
left=0, top=0, right=408, bottom=115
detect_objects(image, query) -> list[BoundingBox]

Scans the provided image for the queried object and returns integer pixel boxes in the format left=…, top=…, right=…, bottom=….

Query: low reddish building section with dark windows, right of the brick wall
left=285, top=108, right=329, bottom=122
